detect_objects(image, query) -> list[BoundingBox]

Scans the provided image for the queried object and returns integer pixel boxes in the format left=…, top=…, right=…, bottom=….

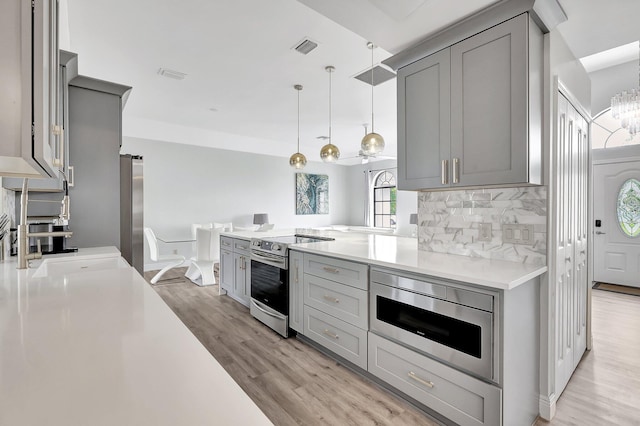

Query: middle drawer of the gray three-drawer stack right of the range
left=304, top=274, right=368, bottom=329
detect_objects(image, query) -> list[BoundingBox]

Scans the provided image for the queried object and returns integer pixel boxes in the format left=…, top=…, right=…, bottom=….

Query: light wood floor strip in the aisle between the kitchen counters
left=145, top=268, right=438, bottom=426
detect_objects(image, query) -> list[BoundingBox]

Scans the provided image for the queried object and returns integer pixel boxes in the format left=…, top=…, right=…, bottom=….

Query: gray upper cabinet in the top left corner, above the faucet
left=0, top=0, right=63, bottom=178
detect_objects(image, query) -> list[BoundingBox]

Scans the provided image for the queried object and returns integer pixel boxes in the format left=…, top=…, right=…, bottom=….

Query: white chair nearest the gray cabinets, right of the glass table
left=184, top=228, right=224, bottom=286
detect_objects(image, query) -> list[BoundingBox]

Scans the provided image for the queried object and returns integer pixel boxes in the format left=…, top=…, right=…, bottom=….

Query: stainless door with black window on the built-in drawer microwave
left=370, top=283, right=494, bottom=380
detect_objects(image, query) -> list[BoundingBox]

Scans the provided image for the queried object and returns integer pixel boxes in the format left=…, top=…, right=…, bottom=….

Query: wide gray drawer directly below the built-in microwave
left=368, top=333, right=502, bottom=426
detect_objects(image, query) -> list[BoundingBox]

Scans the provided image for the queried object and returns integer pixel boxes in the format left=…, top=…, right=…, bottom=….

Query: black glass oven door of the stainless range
left=251, top=253, right=289, bottom=315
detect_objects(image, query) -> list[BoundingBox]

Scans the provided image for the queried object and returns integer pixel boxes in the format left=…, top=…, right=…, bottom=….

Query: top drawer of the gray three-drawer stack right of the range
left=304, top=254, right=369, bottom=290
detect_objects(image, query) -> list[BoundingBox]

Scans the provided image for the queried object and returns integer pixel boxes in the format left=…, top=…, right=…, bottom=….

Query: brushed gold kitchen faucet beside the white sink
left=18, top=178, right=73, bottom=269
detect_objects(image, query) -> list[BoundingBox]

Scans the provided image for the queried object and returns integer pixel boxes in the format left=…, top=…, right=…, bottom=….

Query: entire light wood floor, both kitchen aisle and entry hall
left=145, top=269, right=640, bottom=426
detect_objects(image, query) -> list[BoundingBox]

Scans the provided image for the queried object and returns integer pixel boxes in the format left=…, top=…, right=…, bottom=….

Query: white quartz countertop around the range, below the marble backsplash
left=223, top=229, right=547, bottom=290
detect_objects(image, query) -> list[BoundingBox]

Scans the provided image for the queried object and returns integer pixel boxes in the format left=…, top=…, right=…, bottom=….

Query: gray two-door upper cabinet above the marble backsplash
left=398, top=13, right=543, bottom=190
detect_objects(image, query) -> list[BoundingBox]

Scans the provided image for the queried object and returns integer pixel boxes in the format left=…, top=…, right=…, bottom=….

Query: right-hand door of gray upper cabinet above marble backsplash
left=451, top=14, right=529, bottom=186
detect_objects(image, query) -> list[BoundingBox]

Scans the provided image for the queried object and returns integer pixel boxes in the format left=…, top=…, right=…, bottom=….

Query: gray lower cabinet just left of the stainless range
left=220, top=236, right=251, bottom=307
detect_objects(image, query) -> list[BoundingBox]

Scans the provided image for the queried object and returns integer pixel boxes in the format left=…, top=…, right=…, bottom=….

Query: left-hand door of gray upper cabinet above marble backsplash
left=398, top=49, right=450, bottom=190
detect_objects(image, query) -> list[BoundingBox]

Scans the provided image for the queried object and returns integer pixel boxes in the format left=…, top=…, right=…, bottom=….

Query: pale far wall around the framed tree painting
left=121, top=137, right=352, bottom=235
